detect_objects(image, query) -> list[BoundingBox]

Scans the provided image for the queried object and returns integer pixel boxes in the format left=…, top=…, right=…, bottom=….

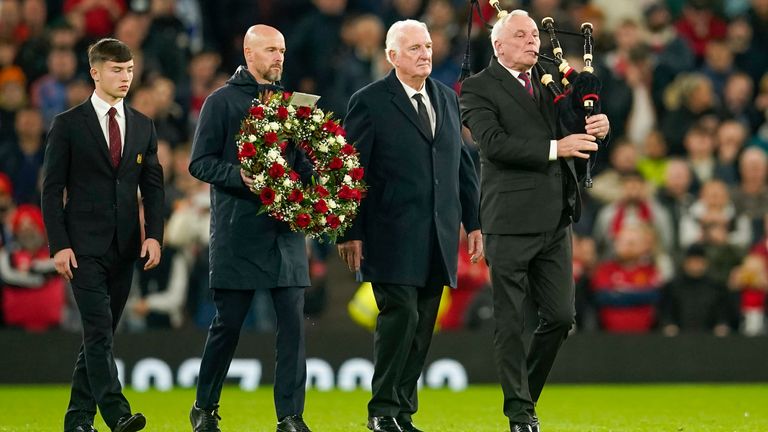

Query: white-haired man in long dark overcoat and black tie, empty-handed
left=338, top=20, right=483, bottom=432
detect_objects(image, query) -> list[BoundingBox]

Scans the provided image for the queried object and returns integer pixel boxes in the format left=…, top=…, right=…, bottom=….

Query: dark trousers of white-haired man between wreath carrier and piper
left=368, top=248, right=445, bottom=422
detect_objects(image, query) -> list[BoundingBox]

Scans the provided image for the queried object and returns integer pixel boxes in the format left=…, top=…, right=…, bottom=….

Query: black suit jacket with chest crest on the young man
left=42, top=99, right=164, bottom=258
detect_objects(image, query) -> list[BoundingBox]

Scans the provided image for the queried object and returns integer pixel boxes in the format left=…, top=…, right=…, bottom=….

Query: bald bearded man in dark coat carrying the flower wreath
left=189, top=25, right=312, bottom=432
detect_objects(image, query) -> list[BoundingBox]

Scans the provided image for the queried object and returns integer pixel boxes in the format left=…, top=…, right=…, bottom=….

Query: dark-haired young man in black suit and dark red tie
left=42, top=39, right=164, bottom=432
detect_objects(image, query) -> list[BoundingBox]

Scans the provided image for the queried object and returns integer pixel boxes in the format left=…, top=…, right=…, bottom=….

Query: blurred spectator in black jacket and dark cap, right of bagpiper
left=659, top=244, right=730, bottom=336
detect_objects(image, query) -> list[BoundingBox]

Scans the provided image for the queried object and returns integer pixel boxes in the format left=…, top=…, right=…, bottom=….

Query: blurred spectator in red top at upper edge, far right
left=675, top=0, right=728, bottom=60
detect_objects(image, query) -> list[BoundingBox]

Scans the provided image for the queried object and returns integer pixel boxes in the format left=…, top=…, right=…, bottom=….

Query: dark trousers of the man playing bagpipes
left=484, top=226, right=576, bottom=423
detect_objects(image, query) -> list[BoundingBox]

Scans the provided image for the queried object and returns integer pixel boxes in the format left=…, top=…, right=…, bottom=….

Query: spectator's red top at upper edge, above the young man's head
left=63, top=0, right=126, bottom=39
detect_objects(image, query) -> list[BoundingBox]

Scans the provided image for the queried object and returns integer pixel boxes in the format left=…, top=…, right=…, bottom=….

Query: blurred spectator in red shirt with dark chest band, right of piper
left=592, top=225, right=662, bottom=333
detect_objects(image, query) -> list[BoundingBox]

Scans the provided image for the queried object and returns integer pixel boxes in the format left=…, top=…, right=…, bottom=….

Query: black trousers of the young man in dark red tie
left=64, top=241, right=135, bottom=431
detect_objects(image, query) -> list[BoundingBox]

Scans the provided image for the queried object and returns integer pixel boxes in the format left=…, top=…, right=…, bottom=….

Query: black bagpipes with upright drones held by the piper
left=459, top=0, right=602, bottom=188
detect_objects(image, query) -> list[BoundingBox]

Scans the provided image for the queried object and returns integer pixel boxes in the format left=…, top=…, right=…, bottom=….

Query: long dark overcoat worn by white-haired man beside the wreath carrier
left=344, top=71, right=479, bottom=287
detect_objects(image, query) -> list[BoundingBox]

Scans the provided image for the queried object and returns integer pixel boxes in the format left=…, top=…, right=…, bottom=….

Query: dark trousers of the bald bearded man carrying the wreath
left=196, top=287, right=307, bottom=419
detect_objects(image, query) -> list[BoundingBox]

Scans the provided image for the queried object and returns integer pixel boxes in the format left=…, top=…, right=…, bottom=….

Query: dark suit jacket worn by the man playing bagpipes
left=461, top=58, right=584, bottom=234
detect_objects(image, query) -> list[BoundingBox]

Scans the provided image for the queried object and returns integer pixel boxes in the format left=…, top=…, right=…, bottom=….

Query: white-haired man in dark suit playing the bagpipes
left=461, top=10, right=609, bottom=432
